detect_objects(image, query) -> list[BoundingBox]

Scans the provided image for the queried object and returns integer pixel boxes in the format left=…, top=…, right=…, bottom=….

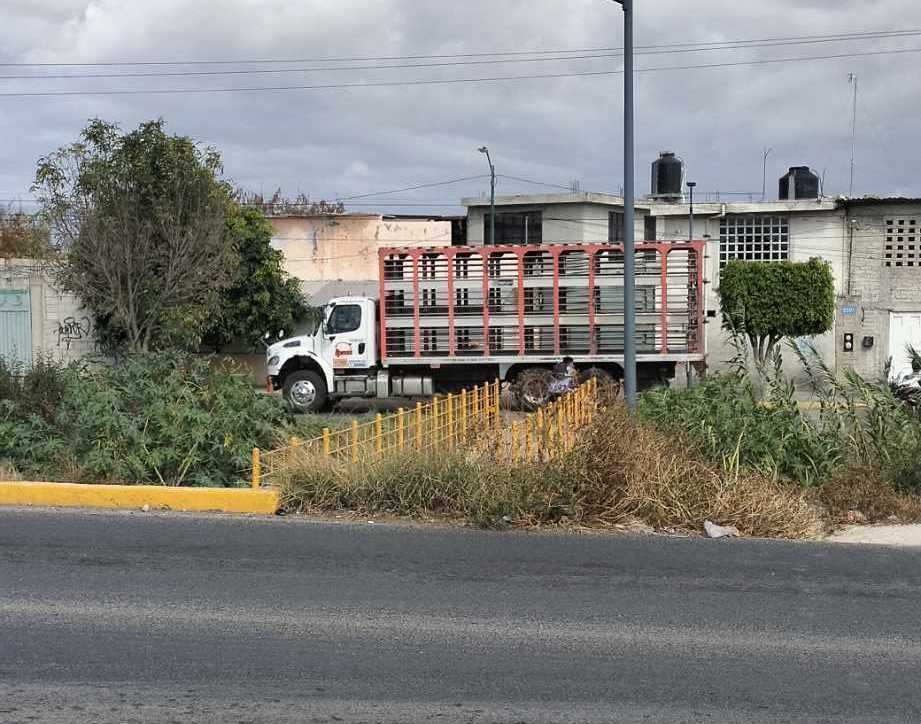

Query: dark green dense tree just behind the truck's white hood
left=203, top=204, right=309, bottom=350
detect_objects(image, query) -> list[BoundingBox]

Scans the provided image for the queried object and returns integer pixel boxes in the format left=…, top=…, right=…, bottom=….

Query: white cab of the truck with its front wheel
left=266, top=297, right=378, bottom=412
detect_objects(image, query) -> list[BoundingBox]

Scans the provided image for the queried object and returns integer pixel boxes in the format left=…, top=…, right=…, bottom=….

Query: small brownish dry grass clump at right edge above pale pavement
left=816, top=465, right=921, bottom=523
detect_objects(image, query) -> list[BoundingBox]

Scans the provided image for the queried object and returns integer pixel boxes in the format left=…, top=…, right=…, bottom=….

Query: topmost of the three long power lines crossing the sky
left=0, top=29, right=921, bottom=68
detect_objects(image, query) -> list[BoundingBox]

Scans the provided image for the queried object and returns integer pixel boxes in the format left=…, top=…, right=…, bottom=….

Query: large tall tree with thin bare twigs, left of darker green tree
left=33, top=119, right=236, bottom=351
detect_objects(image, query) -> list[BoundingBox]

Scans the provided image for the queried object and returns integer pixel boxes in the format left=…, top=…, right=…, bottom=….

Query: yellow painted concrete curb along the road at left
left=0, top=482, right=279, bottom=515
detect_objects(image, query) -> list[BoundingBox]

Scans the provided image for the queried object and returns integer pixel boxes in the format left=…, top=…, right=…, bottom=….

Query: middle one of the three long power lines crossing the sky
left=0, top=30, right=921, bottom=80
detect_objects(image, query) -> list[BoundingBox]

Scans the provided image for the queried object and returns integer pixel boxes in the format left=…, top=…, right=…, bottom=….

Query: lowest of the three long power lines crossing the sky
left=0, top=48, right=921, bottom=98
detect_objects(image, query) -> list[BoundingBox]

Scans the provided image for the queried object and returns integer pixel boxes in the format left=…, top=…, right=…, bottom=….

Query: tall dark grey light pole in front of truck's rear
left=614, top=0, right=636, bottom=415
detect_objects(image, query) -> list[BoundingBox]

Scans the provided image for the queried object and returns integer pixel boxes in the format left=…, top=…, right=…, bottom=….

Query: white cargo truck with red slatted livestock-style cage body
left=266, top=241, right=705, bottom=413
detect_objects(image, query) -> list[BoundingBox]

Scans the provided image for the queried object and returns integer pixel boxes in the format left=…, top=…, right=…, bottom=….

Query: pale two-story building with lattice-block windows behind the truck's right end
left=462, top=167, right=921, bottom=375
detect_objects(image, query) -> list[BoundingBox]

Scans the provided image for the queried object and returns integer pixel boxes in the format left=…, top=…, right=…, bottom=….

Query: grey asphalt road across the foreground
left=0, top=510, right=921, bottom=724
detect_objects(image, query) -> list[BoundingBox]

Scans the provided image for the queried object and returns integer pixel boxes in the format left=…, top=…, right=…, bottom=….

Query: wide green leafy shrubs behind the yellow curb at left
left=0, top=352, right=284, bottom=486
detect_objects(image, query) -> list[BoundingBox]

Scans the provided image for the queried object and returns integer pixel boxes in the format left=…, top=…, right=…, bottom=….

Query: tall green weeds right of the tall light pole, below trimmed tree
left=639, top=345, right=921, bottom=492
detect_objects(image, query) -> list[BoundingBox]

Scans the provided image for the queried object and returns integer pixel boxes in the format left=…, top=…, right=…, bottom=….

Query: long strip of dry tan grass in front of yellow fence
left=274, top=396, right=822, bottom=538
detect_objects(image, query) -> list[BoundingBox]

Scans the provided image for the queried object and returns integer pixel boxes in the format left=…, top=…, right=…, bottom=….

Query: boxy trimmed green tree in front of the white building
left=719, top=258, right=835, bottom=365
